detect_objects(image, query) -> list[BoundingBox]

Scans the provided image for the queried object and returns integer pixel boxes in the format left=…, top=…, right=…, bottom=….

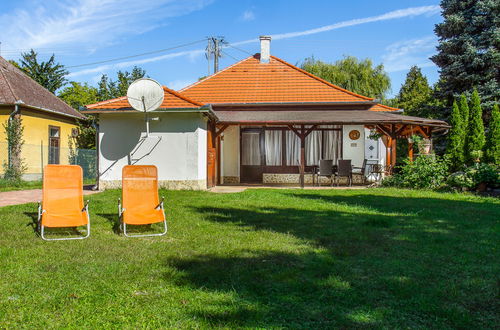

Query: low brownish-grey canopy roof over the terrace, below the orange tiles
left=216, top=110, right=450, bottom=128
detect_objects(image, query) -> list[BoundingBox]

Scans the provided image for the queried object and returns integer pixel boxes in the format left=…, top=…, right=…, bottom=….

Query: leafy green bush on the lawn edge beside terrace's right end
left=382, top=154, right=449, bottom=189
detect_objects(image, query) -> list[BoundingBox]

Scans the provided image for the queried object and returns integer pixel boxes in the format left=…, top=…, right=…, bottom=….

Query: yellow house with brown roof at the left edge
left=0, top=57, right=85, bottom=180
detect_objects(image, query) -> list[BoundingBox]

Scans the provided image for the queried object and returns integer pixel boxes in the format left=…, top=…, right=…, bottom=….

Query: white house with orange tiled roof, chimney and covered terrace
left=86, top=37, right=449, bottom=189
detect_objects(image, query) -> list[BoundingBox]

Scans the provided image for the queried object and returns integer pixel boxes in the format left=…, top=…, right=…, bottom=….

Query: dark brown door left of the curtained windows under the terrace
left=240, top=129, right=264, bottom=183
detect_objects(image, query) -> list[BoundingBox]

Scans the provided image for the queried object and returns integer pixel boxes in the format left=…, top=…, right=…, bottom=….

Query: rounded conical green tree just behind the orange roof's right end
left=396, top=66, right=432, bottom=117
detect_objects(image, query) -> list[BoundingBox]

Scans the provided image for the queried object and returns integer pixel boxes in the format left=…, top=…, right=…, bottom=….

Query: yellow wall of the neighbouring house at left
left=0, top=108, right=77, bottom=175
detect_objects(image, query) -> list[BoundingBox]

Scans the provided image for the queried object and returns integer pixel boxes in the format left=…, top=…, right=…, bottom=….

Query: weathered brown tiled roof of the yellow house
left=0, top=56, right=85, bottom=119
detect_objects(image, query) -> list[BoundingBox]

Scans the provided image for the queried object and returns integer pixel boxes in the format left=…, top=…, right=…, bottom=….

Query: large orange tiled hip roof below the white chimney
left=180, top=54, right=399, bottom=111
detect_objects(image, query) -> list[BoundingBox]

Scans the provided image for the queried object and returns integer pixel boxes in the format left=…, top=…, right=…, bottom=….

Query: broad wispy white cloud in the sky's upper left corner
left=0, top=0, right=211, bottom=51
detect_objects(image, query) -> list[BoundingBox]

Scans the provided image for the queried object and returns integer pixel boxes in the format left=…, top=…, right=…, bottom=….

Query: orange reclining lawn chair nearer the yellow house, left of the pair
left=38, top=165, right=90, bottom=241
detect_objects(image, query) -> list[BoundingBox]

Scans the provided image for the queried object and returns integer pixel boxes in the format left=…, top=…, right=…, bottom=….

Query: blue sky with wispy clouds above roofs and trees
left=0, top=0, right=442, bottom=96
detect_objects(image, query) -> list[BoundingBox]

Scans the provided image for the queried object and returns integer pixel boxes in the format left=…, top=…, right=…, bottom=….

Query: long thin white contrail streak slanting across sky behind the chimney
left=70, top=6, right=440, bottom=76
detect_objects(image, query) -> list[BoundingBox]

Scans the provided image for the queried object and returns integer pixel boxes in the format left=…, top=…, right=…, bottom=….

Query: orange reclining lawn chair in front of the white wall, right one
left=118, top=165, right=167, bottom=237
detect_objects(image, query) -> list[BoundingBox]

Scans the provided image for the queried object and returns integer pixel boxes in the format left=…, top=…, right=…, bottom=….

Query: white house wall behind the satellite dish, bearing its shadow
left=99, top=113, right=207, bottom=190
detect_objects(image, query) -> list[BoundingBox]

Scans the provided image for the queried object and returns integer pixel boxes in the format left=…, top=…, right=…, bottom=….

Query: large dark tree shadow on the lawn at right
left=163, top=192, right=500, bottom=328
